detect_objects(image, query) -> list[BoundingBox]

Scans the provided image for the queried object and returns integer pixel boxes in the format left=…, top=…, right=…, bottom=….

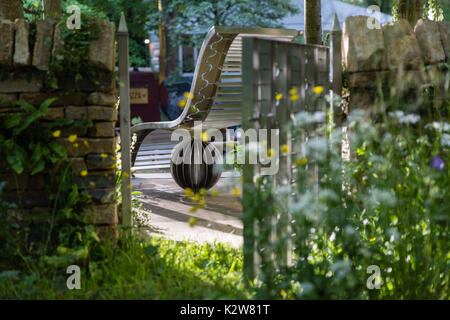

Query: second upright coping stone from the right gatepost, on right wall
left=383, top=20, right=423, bottom=69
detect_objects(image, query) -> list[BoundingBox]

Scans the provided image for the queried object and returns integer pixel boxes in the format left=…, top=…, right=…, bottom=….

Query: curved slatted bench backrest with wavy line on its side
left=131, top=27, right=298, bottom=133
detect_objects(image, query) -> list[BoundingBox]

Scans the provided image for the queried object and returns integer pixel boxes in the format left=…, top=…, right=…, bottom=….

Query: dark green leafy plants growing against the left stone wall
left=0, top=99, right=98, bottom=270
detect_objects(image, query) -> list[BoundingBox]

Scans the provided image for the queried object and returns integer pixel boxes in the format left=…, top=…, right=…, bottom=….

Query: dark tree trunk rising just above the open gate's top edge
left=305, top=0, right=322, bottom=44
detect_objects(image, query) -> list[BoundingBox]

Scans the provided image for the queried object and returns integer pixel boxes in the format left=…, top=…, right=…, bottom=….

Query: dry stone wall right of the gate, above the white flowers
left=342, top=16, right=450, bottom=113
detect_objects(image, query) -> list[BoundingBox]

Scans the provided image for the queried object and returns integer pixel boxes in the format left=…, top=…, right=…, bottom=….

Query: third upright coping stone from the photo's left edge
left=33, top=20, right=54, bottom=70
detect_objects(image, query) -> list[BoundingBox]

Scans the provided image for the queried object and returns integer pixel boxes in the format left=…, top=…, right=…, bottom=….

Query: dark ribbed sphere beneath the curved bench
left=170, top=139, right=222, bottom=192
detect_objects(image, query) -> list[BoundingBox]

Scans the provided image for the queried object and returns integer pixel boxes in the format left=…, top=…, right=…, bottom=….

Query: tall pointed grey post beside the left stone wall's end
left=118, top=12, right=132, bottom=226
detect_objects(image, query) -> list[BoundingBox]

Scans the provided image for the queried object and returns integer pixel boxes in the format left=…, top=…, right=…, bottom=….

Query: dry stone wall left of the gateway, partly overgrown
left=0, top=19, right=118, bottom=235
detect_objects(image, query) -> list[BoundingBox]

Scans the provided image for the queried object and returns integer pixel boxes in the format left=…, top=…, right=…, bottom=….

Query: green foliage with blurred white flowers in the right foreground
left=244, top=68, right=450, bottom=300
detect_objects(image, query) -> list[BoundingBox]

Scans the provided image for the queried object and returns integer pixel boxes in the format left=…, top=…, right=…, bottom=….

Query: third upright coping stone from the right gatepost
left=414, top=19, right=445, bottom=64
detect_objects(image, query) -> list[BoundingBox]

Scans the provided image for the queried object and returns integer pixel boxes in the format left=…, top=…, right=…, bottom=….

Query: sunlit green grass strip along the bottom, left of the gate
left=0, top=238, right=251, bottom=300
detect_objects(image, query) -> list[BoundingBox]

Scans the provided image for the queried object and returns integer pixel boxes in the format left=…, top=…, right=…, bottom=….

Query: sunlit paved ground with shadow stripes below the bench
left=133, top=172, right=243, bottom=247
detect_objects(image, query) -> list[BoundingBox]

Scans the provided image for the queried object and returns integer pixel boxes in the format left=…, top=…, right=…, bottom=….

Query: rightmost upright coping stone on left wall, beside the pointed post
left=89, top=20, right=116, bottom=73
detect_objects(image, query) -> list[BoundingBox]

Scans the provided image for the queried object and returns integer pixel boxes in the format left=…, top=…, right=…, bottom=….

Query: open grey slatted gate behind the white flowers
left=242, top=19, right=342, bottom=279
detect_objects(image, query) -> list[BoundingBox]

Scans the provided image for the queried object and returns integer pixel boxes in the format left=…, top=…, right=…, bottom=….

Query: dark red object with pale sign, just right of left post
left=130, top=71, right=169, bottom=122
